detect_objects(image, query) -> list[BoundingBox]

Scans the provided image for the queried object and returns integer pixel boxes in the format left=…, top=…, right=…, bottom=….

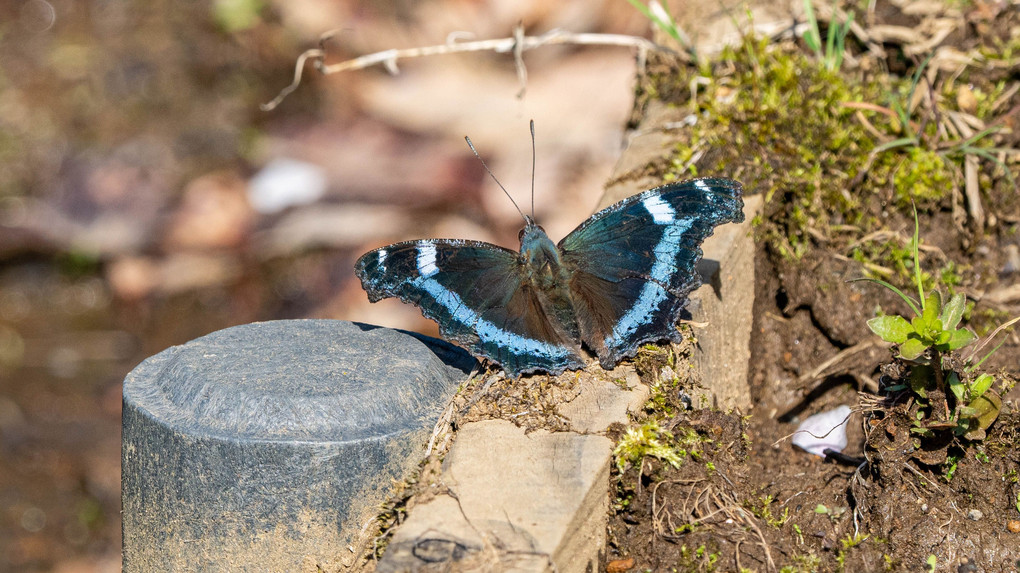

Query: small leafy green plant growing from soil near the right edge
left=861, top=209, right=1020, bottom=438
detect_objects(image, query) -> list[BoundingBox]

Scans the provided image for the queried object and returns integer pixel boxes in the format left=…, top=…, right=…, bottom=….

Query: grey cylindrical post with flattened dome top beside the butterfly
left=121, top=320, right=475, bottom=572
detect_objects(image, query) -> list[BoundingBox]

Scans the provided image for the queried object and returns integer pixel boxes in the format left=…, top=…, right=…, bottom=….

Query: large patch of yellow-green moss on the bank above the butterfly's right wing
left=646, top=34, right=1003, bottom=278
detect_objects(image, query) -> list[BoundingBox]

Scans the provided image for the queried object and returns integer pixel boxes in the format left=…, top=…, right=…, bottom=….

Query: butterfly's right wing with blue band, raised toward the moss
left=559, top=178, right=744, bottom=368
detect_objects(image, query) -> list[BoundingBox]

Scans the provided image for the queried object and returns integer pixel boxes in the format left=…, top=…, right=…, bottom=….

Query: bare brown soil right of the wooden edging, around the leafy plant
left=606, top=5, right=1020, bottom=573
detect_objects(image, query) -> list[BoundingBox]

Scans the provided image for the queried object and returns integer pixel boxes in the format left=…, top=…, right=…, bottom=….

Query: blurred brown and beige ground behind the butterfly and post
left=0, top=0, right=673, bottom=573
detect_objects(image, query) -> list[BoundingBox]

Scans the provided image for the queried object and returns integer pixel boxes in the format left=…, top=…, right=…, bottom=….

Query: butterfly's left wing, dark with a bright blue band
left=355, top=240, right=584, bottom=376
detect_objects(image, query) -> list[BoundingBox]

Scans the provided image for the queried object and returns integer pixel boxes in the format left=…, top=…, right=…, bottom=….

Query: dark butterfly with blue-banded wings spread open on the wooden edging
left=355, top=175, right=744, bottom=377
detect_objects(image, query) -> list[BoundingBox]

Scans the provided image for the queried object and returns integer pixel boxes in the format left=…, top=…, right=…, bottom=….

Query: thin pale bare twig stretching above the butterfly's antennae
left=260, top=24, right=681, bottom=111
